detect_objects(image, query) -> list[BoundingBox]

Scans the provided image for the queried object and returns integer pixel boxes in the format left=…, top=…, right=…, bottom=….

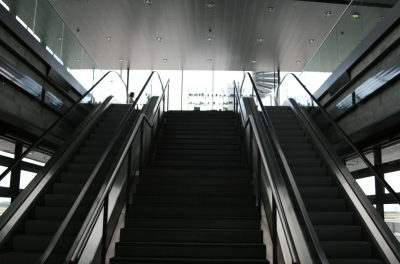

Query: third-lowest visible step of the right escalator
left=314, top=225, right=362, bottom=241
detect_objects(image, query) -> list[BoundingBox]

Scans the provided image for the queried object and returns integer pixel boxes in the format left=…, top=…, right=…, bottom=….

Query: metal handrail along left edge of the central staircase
left=64, top=80, right=169, bottom=263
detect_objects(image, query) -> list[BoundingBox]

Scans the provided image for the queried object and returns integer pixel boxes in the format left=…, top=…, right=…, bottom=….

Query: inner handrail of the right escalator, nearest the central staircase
left=241, top=73, right=329, bottom=264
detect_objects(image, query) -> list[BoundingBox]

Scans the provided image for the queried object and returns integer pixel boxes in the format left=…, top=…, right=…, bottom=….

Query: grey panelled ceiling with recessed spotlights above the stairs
left=50, top=0, right=346, bottom=71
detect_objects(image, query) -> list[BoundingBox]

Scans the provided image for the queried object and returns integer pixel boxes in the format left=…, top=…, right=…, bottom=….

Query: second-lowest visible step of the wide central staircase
left=115, top=242, right=265, bottom=259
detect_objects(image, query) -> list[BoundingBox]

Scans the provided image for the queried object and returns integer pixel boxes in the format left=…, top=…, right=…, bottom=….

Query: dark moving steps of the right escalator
left=266, top=107, right=384, bottom=264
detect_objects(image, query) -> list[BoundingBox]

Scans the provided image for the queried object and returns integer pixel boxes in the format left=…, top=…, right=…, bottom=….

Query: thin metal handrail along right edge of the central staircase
left=233, top=82, right=300, bottom=264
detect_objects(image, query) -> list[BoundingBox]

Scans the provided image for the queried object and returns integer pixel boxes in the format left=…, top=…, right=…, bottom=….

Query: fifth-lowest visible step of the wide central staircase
left=129, top=204, right=259, bottom=217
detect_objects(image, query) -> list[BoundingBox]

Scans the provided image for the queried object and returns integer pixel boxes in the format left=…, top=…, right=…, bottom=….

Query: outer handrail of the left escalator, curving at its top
left=0, top=71, right=127, bottom=184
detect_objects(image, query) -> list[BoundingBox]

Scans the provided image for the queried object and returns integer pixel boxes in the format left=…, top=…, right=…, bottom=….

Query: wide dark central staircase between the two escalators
left=110, top=111, right=268, bottom=264
